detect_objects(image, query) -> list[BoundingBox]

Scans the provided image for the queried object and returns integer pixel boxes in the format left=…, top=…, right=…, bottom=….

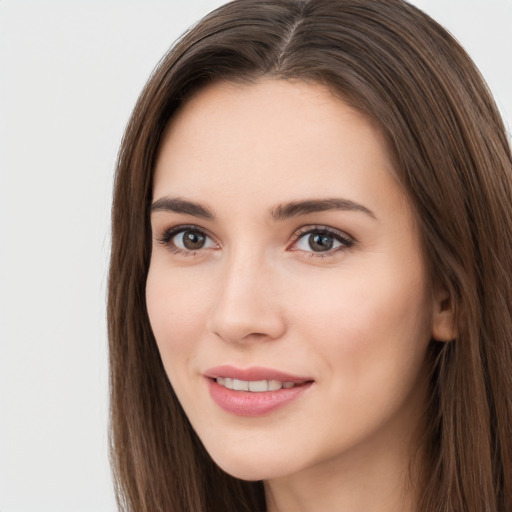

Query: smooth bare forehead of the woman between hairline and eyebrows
left=154, top=79, right=405, bottom=219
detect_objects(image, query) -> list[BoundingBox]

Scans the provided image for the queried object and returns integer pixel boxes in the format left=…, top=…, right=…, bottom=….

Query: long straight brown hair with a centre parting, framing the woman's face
left=108, top=0, right=512, bottom=512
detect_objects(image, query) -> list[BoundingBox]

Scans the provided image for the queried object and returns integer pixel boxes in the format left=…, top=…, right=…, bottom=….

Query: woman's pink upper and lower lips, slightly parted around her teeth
left=203, top=365, right=314, bottom=416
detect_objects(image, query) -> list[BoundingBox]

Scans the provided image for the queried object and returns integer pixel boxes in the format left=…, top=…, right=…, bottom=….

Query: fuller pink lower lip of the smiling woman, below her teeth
left=207, top=379, right=313, bottom=416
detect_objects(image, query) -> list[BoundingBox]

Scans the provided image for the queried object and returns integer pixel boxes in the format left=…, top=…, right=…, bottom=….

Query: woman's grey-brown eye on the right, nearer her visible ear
left=291, top=226, right=354, bottom=256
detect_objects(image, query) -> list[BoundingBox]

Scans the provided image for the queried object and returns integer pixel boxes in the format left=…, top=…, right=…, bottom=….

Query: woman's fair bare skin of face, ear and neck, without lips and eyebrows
left=146, top=79, right=450, bottom=512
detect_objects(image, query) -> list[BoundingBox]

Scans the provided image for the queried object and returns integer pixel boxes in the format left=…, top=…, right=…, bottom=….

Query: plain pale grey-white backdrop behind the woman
left=0, top=0, right=512, bottom=512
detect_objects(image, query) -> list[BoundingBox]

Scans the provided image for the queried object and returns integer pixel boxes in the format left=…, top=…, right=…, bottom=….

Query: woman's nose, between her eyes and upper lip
left=208, top=251, right=286, bottom=343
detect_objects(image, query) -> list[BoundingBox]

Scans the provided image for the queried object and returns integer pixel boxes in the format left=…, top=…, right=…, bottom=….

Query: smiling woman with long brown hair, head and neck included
left=109, top=0, right=512, bottom=512
